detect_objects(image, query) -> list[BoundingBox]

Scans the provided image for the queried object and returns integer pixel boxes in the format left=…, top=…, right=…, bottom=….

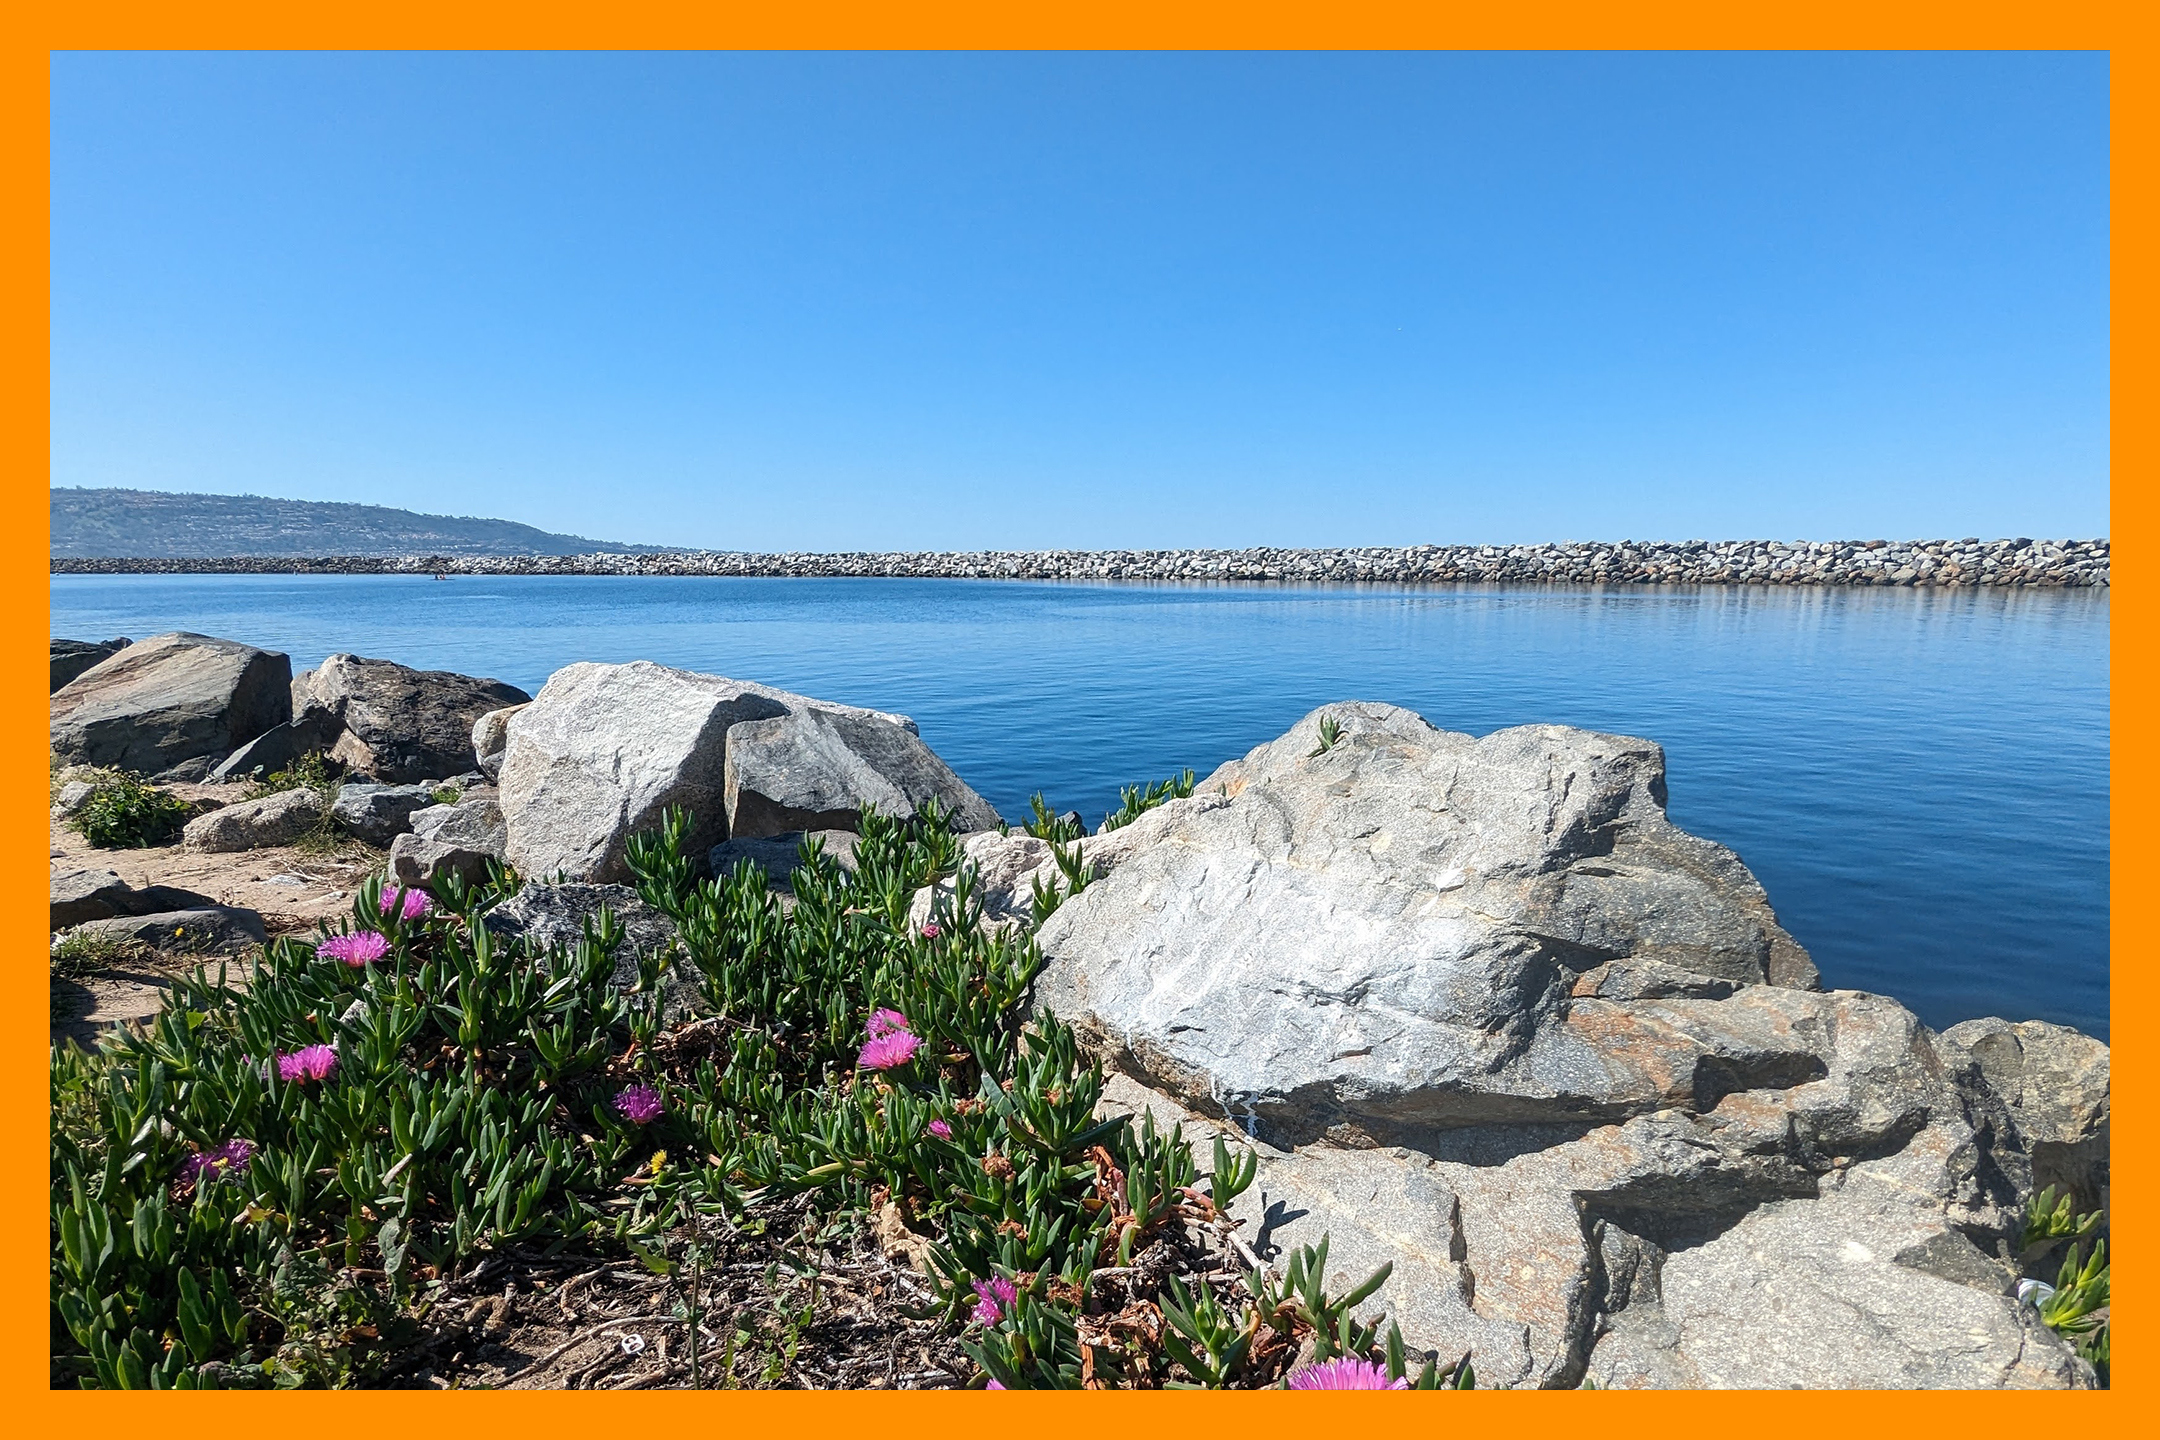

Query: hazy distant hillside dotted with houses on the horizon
left=52, top=490, right=665, bottom=559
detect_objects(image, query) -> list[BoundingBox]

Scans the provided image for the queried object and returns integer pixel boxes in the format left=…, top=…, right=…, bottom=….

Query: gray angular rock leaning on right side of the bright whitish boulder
left=724, top=708, right=998, bottom=838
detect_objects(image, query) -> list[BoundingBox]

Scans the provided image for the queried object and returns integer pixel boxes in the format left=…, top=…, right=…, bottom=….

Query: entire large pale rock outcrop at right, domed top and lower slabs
left=1045, top=704, right=2093, bottom=1388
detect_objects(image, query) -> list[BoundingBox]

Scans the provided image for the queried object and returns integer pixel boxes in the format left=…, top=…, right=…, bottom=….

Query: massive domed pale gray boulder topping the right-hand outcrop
left=1037, top=704, right=1819, bottom=1142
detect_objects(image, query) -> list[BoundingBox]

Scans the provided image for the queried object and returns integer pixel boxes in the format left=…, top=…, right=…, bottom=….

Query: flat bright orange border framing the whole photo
left=0, top=11, right=2125, bottom=1436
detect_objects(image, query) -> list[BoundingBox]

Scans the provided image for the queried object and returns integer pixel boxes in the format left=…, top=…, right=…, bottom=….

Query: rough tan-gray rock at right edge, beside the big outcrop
left=1942, top=1017, right=2110, bottom=1209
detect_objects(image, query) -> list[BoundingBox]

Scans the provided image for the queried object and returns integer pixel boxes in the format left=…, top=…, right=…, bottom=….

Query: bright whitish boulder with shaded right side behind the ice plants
left=501, top=661, right=972, bottom=881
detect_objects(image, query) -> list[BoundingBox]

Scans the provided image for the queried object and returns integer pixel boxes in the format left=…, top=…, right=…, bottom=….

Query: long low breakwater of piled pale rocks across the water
left=52, top=538, right=2108, bottom=589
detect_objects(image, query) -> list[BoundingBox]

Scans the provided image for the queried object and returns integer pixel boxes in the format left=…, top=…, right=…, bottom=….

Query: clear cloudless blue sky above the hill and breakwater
left=52, top=54, right=2108, bottom=551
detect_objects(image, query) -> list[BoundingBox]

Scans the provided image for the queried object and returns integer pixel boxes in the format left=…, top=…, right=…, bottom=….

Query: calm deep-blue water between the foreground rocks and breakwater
left=52, top=576, right=2108, bottom=1036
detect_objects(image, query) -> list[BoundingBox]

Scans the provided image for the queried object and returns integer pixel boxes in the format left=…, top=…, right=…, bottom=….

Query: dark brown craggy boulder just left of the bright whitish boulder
left=292, top=654, right=531, bottom=784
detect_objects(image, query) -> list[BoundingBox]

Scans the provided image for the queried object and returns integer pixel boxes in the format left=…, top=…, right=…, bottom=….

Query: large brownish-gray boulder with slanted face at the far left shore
left=52, top=630, right=292, bottom=779
